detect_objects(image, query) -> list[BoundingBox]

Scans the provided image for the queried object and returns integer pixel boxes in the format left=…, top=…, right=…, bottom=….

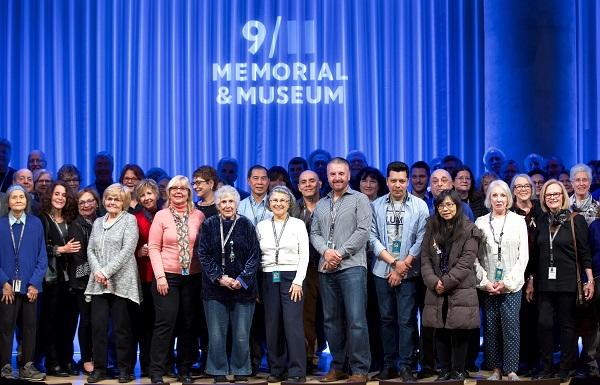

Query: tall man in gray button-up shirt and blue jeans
left=310, top=158, right=371, bottom=382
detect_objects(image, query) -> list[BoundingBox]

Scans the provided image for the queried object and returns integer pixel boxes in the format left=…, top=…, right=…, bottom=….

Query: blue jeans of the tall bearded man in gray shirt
left=319, top=266, right=371, bottom=374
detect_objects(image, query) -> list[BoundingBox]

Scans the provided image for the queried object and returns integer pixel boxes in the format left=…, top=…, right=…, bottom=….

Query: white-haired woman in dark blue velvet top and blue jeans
left=198, top=185, right=260, bottom=383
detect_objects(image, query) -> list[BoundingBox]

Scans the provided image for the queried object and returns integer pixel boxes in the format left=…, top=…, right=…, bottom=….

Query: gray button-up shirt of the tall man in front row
left=310, top=188, right=371, bottom=273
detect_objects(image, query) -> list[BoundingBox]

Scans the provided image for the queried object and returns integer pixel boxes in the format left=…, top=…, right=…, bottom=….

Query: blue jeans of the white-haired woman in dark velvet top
left=204, top=300, right=254, bottom=376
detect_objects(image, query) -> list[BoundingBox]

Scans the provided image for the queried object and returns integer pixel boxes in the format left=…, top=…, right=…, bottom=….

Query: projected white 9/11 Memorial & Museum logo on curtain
left=212, top=16, right=348, bottom=104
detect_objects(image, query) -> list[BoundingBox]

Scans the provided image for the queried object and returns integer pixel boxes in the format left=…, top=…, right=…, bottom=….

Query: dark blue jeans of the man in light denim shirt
left=375, top=276, right=418, bottom=368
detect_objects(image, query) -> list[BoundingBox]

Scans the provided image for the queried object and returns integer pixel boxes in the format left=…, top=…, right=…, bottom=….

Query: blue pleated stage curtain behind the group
left=0, top=0, right=598, bottom=180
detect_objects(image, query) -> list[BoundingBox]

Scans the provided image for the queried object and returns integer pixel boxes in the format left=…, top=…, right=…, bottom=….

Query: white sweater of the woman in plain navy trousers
left=256, top=217, right=308, bottom=285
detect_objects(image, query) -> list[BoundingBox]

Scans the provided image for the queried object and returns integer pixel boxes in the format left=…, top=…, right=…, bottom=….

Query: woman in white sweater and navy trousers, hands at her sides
left=256, top=186, right=308, bottom=382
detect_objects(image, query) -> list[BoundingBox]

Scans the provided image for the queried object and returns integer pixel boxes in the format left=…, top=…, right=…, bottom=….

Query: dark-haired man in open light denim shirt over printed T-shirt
left=369, top=162, right=429, bottom=382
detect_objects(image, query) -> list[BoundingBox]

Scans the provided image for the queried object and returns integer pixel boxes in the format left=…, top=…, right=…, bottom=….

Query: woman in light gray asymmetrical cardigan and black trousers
left=85, top=183, right=141, bottom=383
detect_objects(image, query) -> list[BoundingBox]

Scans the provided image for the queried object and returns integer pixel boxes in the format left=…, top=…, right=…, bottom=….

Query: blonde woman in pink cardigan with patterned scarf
left=148, top=175, right=204, bottom=384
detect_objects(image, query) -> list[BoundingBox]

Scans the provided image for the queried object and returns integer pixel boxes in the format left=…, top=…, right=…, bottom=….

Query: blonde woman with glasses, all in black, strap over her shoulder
left=527, top=179, right=594, bottom=382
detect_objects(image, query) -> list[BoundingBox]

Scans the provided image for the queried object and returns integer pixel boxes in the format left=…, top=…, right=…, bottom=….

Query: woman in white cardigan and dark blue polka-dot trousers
left=475, top=180, right=529, bottom=380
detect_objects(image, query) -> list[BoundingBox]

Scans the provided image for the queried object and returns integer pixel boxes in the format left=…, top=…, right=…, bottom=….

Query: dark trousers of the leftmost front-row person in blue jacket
left=0, top=294, right=38, bottom=367
